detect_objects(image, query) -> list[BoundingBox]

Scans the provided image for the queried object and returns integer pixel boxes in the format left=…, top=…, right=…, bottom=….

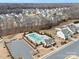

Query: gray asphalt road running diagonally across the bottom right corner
left=46, top=40, right=79, bottom=59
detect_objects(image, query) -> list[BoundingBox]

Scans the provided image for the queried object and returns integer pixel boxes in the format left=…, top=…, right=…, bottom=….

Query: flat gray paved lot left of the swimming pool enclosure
left=7, top=40, right=33, bottom=59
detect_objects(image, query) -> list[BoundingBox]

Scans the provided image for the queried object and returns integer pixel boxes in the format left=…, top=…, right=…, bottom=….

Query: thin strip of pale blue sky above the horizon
left=0, top=0, right=79, bottom=3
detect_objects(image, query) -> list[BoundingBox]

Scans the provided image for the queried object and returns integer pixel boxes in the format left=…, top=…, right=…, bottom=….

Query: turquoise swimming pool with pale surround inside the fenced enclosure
left=26, top=32, right=45, bottom=44
